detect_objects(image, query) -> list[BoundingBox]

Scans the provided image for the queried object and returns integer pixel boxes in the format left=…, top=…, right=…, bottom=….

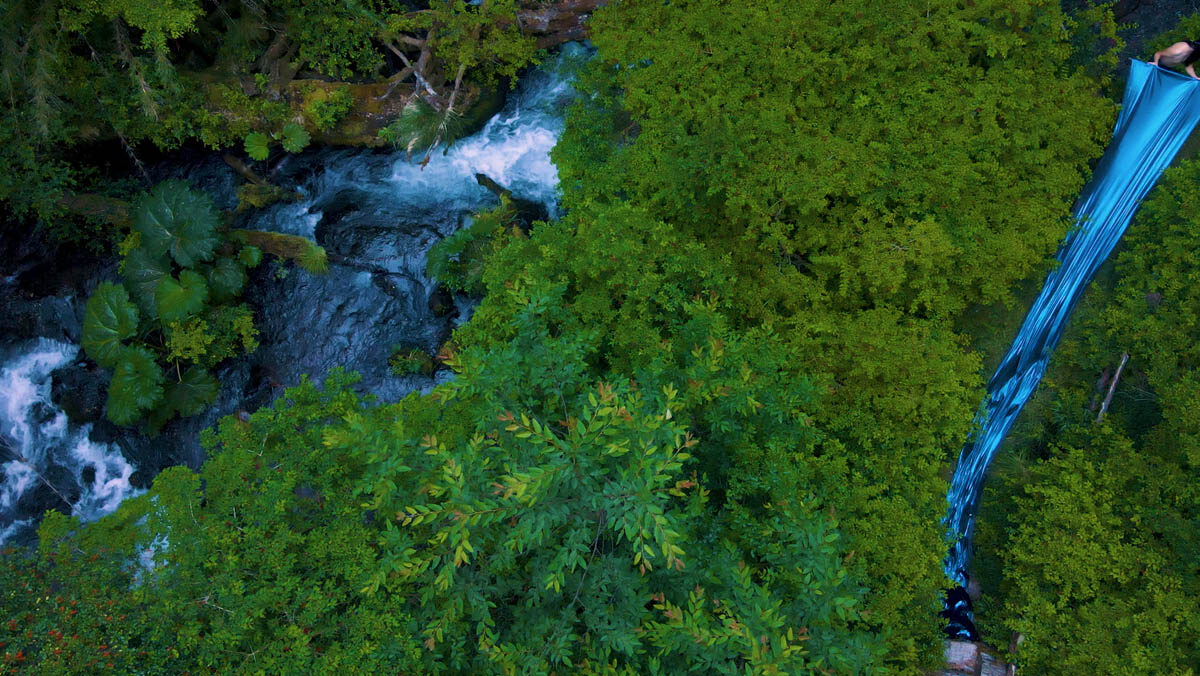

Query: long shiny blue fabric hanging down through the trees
left=946, top=60, right=1200, bottom=584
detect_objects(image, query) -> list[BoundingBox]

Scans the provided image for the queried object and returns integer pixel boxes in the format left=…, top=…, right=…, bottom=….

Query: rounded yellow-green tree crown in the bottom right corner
left=990, top=430, right=1200, bottom=675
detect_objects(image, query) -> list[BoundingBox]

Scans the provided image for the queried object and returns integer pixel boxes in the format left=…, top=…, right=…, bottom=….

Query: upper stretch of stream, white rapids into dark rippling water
left=225, top=44, right=589, bottom=408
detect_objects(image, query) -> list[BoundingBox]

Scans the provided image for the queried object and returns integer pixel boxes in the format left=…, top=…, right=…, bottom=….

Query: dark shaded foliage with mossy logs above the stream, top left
left=0, top=0, right=534, bottom=229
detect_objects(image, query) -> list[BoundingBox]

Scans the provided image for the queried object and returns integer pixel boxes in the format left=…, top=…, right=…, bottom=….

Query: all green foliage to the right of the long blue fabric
left=979, top=160, right=1200, bottom=675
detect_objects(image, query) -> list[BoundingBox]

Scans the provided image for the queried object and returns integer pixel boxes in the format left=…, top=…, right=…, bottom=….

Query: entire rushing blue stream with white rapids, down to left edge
left=0, top=44, right=589, bottom=542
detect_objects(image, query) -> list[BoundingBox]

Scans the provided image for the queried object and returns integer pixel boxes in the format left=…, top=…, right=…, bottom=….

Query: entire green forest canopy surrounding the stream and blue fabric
left=0, top=0, right=1200, bottom=675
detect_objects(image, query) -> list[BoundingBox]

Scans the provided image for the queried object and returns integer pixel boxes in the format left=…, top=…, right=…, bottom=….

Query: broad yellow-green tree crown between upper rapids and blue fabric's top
left=556, top=0, right=1115, bottom=315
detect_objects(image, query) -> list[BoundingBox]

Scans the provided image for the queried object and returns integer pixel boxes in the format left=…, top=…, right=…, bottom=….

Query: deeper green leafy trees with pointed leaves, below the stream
left=5, top=288, right=883, bottom=674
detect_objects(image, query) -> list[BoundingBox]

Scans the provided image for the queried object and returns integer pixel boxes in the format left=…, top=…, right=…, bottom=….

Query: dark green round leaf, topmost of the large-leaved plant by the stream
left=133, top=180, right=218, bottom=268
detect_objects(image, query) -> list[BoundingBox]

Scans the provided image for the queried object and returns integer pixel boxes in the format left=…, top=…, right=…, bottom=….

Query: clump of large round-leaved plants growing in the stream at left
left=83, top=181, right=262, bottom=429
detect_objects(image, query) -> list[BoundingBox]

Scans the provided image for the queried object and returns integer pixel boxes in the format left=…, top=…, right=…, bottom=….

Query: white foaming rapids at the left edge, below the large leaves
left=0, top=339, right=134, bottom=543
